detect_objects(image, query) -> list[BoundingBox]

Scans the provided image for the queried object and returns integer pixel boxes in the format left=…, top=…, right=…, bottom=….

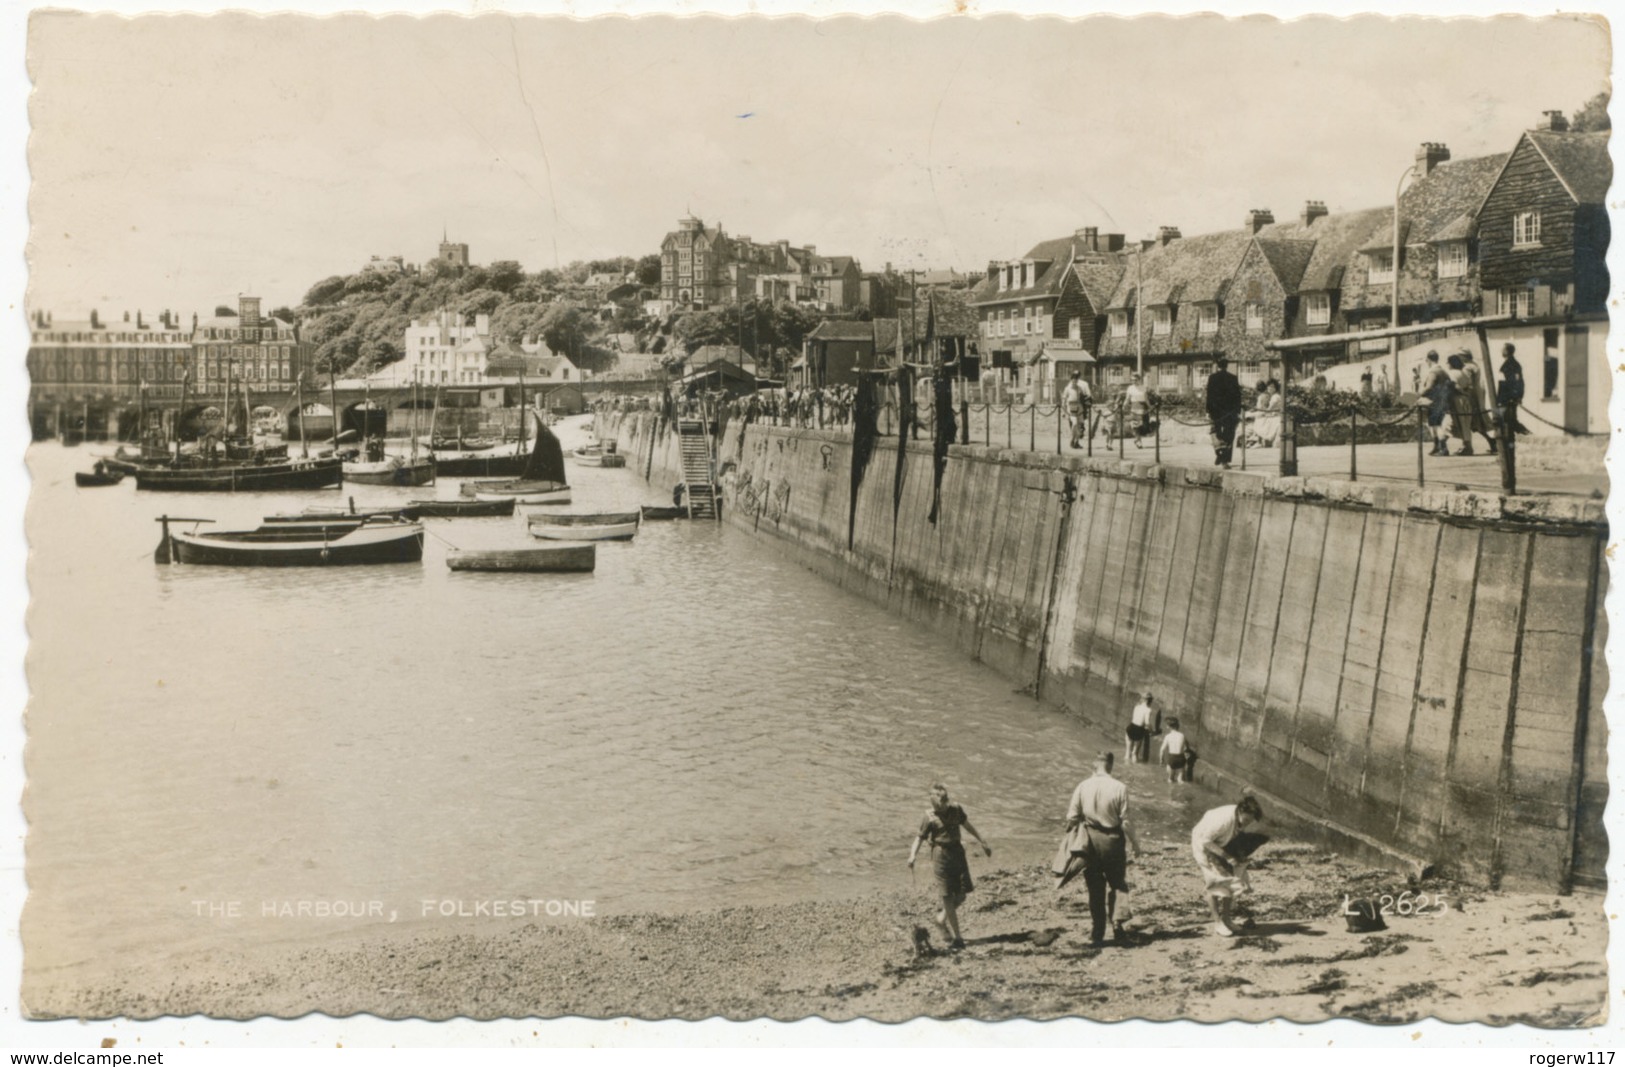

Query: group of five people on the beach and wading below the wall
left=908, top=692, right=1269, bottom=948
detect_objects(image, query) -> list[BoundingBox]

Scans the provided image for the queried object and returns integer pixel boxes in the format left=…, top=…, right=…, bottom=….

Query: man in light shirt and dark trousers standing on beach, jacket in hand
left=1055, top=750, right=1139, bottom=945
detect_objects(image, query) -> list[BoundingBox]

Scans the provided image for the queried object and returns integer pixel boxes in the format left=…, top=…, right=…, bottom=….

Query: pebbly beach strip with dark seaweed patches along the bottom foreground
left=23, top=841, right=1607, bottom=1028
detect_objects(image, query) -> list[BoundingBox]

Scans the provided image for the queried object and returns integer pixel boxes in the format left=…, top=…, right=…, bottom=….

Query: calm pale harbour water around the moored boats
left=24, top=427, right=1222, bottom=974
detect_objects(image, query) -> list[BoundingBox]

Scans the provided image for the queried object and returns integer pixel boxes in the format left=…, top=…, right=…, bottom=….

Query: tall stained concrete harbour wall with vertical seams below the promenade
left=601, top=414, right=1607, bottom=890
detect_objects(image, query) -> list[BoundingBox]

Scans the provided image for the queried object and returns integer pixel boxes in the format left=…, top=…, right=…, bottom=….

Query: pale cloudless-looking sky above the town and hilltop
left=15, top=13, right=1610, bottom=317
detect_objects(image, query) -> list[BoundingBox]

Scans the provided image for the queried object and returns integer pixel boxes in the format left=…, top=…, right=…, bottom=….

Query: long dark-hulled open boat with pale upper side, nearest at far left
left=153, top=515, right=423, bottom=567
